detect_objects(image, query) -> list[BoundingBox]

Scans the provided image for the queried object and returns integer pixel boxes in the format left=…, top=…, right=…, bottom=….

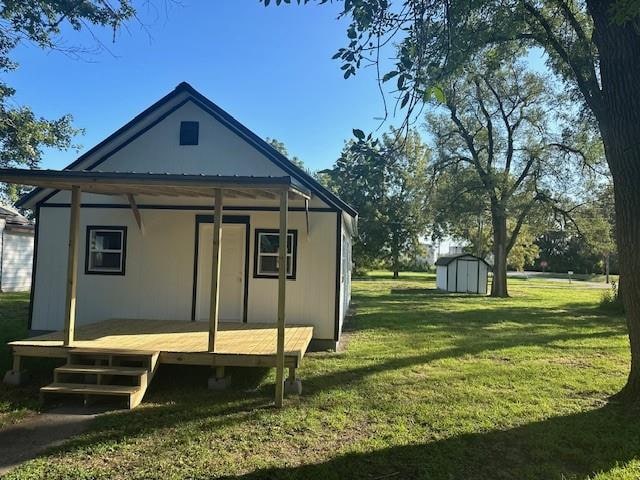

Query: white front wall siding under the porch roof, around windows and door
left=31, top=204, right=337, bottom=339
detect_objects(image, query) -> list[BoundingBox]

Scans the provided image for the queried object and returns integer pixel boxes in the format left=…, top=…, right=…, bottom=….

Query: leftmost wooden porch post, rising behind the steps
left=64, top=186, right=81, bottom=346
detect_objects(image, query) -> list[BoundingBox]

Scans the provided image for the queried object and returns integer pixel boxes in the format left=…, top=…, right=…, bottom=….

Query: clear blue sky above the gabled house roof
left=7, top=0, right=396, bottom=173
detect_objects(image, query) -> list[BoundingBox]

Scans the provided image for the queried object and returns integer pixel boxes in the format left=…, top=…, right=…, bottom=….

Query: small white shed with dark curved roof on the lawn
left=436, top=253, right=491, bottom=294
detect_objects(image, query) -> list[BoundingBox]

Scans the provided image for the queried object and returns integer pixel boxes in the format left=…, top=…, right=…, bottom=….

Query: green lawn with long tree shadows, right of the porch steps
left=1, top=274, right=640, bottom=480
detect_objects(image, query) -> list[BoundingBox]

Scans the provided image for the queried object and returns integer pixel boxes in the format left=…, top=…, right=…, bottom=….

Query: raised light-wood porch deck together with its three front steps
left=9, top=319, right=313, bottom=408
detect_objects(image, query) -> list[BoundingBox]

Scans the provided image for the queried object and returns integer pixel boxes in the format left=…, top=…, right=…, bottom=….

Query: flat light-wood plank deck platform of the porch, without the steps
left=9, top=319, right=313, bottom=368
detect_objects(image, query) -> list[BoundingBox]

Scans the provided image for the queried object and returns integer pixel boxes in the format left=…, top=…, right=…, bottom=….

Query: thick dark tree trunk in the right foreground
left=588, top=0, right=640, bottom=401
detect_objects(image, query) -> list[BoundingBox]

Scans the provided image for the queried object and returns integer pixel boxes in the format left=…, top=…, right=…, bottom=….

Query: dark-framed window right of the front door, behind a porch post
left=253, top=230, right=298, bottom=280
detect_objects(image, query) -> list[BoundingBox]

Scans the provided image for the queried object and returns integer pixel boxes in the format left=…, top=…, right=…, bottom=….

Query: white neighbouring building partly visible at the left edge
left=0, top=205, right=34, bottom=292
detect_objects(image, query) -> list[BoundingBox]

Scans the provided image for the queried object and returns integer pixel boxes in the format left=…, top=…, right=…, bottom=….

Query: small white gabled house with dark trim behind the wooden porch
left=12, top=83, right=357, bottom=347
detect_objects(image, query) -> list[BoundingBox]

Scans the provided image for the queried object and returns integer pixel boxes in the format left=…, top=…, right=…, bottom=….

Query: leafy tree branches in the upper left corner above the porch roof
left=0, top=0, right=134, bottom=202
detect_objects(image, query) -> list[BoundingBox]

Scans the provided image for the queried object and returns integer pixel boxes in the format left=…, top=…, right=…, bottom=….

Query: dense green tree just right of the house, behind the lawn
left=322, top=129, right=429, bottom=278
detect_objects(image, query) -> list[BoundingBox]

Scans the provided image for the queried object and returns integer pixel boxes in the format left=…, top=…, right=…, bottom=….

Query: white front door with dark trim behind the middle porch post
left=196, top=223, right=246, bottom=322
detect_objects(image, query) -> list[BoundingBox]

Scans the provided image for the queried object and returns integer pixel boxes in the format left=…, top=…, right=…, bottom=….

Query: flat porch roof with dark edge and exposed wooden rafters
left=0, top=168, right=311, bottom=200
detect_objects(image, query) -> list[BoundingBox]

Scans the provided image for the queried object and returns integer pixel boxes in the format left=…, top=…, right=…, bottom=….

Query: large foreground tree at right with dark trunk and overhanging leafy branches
left=262, top=0, right=640, bottom=401
